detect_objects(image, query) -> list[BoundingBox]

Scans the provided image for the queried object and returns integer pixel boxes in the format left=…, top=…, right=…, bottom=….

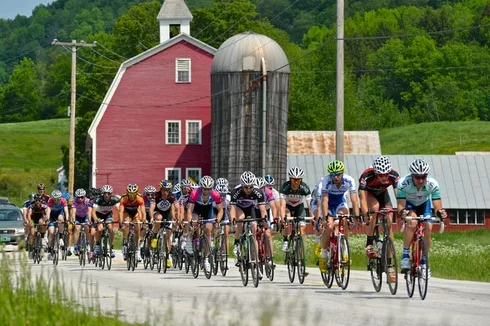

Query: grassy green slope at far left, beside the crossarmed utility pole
left=0, top=119, right=69, bottom=205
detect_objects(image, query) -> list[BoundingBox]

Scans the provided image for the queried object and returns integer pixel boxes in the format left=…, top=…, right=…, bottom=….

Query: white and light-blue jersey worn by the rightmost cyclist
left=396, top=174, right=441, bottom=206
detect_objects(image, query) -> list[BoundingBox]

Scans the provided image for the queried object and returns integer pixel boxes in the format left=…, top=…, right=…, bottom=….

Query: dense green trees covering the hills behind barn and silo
left=0, top=0, right=490, bottom=185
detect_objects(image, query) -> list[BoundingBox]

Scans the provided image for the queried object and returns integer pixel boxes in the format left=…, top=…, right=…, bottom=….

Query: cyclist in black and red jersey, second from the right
left=359, top=156, right=400, bottom=258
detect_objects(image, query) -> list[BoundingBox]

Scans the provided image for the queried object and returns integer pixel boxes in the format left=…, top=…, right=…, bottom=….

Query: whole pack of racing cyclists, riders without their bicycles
left=23, top=156, right=447, bottom=280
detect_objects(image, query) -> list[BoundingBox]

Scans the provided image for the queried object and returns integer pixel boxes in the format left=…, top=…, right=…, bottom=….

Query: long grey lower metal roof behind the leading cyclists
left=288, top=155, right=490, bottom=209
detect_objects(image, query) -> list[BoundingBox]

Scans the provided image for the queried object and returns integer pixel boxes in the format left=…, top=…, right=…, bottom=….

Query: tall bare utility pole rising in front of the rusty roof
left=335, top=0, right=344, bottom=161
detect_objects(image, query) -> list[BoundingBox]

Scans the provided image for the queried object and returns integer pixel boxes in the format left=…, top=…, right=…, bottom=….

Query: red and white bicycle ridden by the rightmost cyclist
left=401, top=216, right=445, bottom=300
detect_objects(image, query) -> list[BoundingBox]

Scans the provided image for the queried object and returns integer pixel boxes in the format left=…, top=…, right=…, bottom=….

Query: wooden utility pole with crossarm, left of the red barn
left=51, top=39, right=97, bottom=198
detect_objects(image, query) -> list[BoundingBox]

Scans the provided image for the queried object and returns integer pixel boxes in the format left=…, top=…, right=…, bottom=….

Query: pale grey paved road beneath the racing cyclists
left=10, top=250, right=490, bottom=326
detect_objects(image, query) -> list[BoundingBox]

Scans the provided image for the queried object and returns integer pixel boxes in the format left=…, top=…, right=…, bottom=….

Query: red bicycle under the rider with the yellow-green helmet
left=320, top=214, right=353, bottom=290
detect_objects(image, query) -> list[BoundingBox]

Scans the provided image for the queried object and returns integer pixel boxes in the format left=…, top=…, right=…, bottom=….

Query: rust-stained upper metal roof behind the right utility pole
left=288, top=131, right=381, bottom=155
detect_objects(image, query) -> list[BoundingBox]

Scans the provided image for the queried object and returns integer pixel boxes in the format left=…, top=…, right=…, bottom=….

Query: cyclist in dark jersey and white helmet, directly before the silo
left=230, top=171, right=267, bottom=272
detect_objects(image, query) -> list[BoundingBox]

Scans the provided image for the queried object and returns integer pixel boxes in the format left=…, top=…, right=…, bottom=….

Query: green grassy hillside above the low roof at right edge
left=379, top=121, right=490, bottom=155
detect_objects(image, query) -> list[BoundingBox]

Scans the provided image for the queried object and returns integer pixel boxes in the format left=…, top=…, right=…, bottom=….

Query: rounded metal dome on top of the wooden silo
left=211, top=32, right=290, bottom=73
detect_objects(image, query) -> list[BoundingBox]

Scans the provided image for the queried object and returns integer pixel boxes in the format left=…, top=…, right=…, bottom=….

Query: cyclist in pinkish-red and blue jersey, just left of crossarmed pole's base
left=47, top=190, right=71, bottom=260
